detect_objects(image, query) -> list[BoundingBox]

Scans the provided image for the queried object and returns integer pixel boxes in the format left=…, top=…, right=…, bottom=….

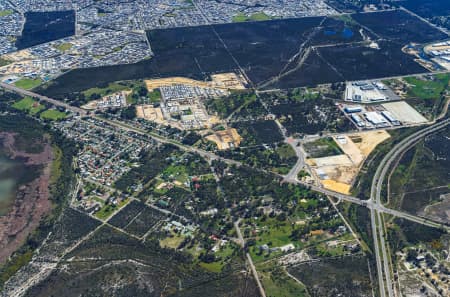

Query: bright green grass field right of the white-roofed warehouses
left=404, top=73, right=450, bottom=99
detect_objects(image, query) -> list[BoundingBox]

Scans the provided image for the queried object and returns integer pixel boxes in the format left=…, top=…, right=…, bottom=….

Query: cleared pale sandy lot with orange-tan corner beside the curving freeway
left=307, top=130, right=390, bottom=194
